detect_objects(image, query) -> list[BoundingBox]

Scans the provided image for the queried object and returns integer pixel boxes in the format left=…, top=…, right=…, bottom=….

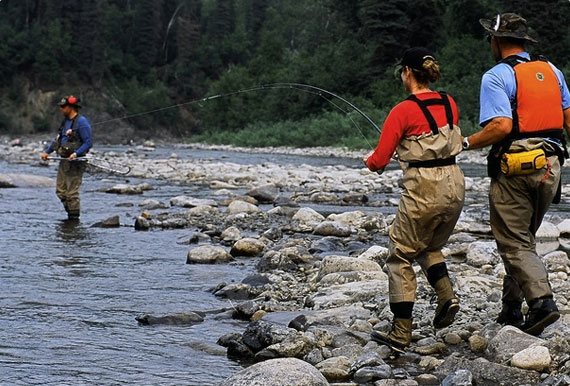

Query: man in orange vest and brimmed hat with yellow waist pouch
left=463, top=13, right=570, bottom=335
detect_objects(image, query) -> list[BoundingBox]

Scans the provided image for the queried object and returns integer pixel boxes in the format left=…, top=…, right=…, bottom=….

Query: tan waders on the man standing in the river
left=56, top=160, right=86, bottom=219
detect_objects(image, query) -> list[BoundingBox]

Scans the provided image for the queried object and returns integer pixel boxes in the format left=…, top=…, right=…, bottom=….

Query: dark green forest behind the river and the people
left=0, top=0, right=570, bottom=148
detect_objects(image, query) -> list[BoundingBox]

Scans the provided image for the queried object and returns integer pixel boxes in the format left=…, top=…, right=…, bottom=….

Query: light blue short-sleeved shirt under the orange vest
left=479, top=52, right=570, bottom=126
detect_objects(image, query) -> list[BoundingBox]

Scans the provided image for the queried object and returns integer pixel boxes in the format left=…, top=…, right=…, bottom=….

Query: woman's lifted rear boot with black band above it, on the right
left=427, top=263, right=459, bottom=328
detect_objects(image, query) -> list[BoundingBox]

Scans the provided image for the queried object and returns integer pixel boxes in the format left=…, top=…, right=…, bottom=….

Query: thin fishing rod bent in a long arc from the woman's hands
left=92, top=82, right=382, bottom=148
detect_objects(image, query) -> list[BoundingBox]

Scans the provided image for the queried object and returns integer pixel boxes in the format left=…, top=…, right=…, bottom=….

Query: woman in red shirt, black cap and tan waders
left=364, top=47, right=465, bottom=352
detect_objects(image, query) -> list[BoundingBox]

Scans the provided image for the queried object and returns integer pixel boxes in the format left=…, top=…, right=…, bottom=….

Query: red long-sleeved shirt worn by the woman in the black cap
left=366, top=91, right=459, bottom=172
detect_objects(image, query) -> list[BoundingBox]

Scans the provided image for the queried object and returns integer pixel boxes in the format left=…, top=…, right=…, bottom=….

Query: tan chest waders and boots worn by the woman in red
left=372, top=119, right=465, bottom=352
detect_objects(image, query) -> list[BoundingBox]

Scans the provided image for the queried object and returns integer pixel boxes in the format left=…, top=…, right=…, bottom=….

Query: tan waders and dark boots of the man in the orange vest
left=489, top=139, right=561, bottom=335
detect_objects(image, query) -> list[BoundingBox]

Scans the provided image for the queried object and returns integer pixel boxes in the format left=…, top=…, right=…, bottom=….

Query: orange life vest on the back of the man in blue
left=503, top=55, right=564, bottom=137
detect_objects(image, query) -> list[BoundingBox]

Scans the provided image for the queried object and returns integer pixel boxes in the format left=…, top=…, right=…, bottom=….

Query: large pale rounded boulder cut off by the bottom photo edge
left=218, top=358, right=329, bottom=386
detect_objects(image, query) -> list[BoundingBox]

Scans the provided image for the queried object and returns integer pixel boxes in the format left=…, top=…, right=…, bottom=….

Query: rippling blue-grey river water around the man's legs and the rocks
left=0, top=147, right=568, bottom=385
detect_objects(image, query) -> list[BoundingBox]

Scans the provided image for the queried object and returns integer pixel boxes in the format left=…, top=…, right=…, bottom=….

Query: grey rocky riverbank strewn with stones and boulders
left=0, top=140, right=570, bottom=385
